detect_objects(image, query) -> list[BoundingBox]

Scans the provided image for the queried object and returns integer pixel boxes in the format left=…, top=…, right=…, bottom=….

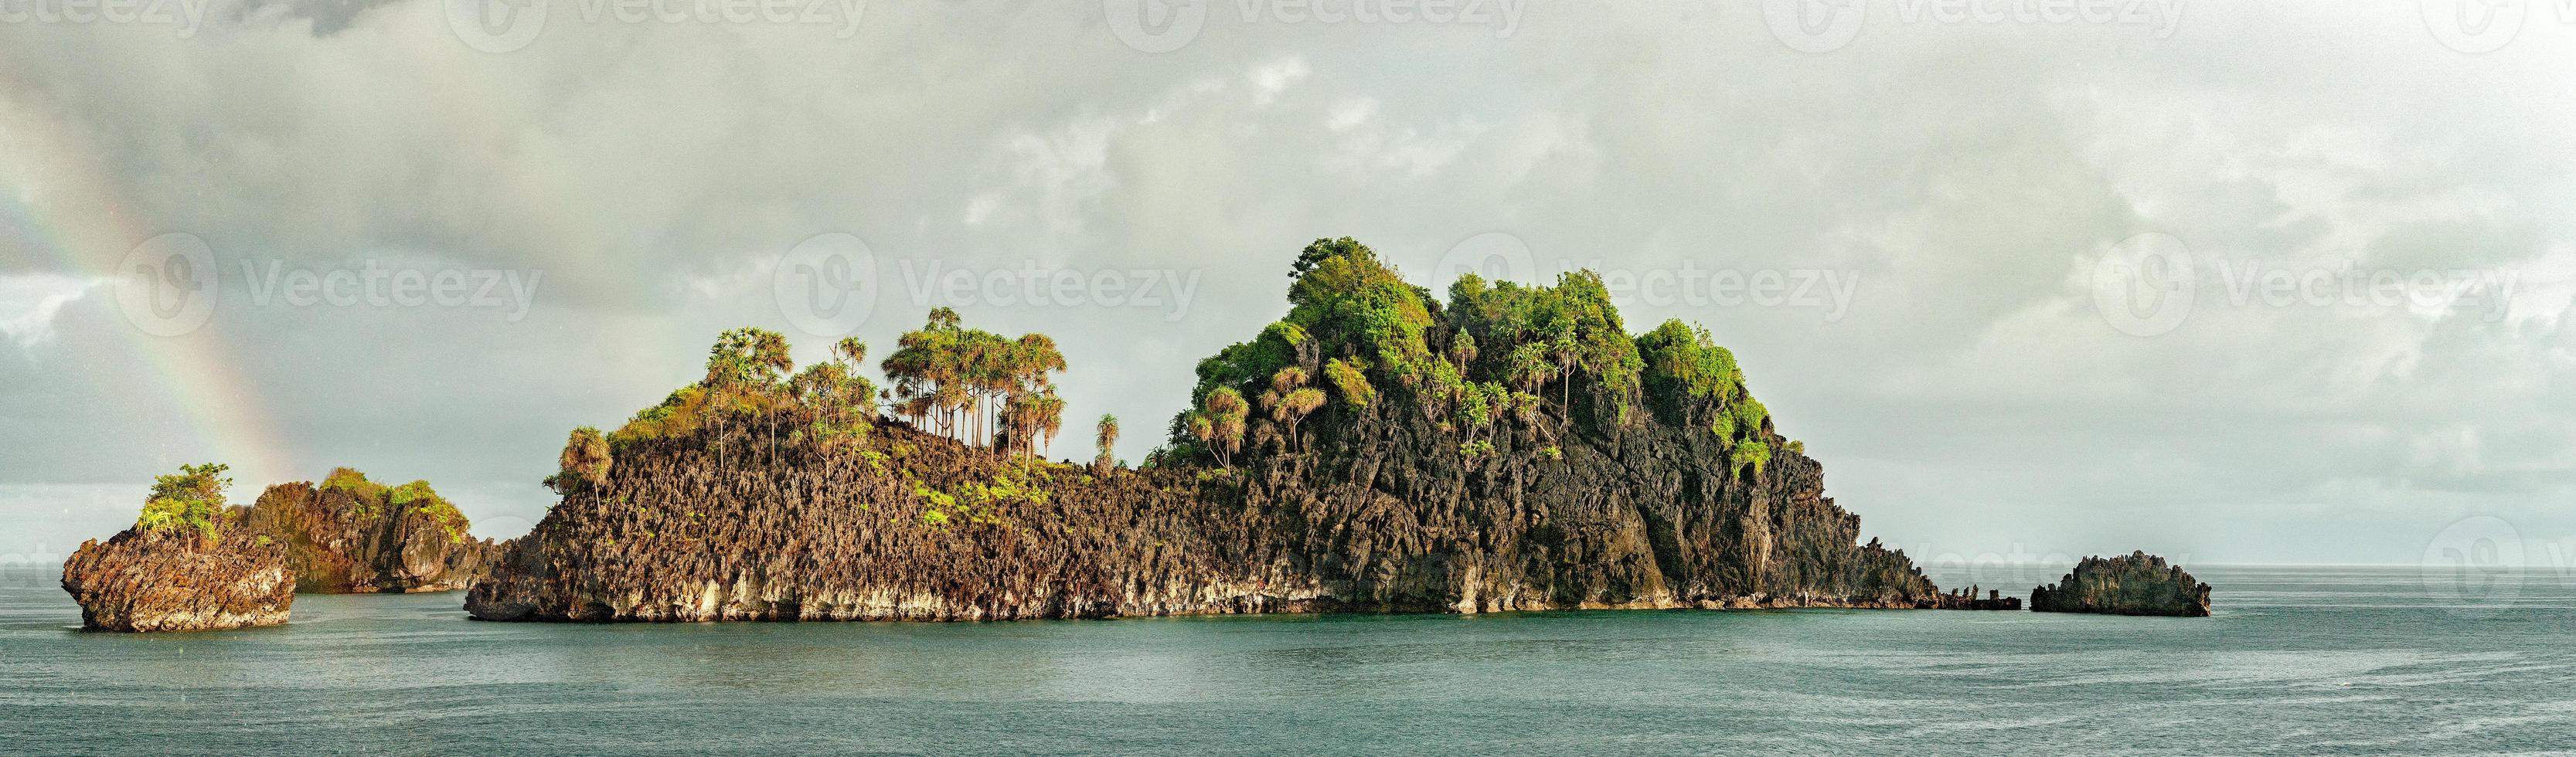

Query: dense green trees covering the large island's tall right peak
left=1146, top=237, right=1772, bottom=471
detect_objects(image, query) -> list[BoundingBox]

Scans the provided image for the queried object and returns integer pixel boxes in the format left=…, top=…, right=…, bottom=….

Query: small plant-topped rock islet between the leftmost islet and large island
left=247, top=469, right=500, bottom=595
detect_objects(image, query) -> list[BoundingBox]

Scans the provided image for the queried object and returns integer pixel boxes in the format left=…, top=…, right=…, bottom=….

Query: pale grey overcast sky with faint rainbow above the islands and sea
left=0, top=0, right=2576, bottom=566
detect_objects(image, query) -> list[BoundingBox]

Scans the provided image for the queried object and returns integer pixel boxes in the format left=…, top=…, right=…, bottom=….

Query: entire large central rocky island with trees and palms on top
left=466, top=239, right=1975, bottom=620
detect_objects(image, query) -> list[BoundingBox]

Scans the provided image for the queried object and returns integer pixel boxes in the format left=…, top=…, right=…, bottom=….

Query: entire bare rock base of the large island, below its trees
left=466, top=417, right=1965, bottom=620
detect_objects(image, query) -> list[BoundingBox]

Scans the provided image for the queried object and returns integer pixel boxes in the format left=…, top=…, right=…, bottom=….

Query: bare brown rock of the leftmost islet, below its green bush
left=62, top=525, right=296, bottom=631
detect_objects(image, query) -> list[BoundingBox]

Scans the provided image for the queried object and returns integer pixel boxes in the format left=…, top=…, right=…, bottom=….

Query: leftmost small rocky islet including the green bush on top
left=62, top=463, right=296, bottom=631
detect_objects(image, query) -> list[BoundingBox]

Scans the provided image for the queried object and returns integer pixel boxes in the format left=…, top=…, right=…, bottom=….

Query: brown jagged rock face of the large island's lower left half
left=466, top=427, right=1324, bottom=620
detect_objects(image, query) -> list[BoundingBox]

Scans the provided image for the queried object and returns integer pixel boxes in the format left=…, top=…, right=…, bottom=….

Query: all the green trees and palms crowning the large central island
left=563, top=237, right=1798, bottom=494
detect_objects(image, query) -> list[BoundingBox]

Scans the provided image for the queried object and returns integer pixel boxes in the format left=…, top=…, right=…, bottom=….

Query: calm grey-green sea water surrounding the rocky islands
left=0, top=566, right=2576, bottom=755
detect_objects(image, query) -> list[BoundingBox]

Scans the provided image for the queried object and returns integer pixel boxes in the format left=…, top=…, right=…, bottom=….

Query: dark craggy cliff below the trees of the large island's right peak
left=1219, top=383, right=1940, bottom=613
